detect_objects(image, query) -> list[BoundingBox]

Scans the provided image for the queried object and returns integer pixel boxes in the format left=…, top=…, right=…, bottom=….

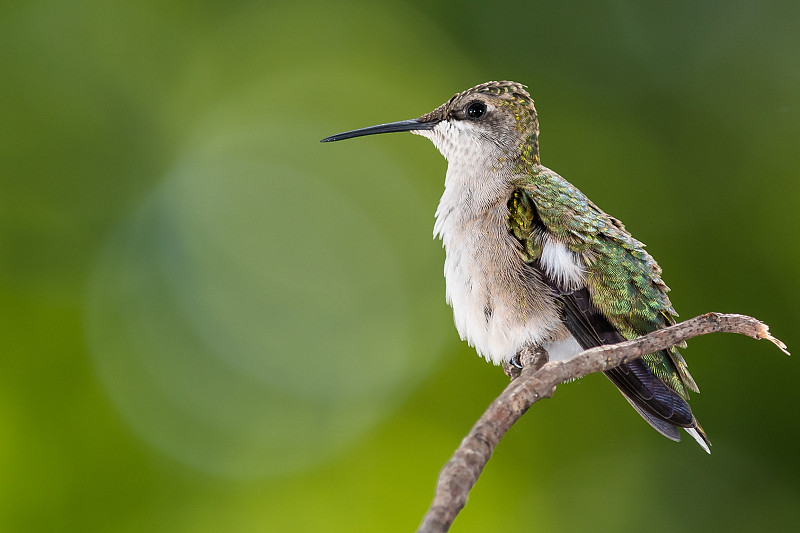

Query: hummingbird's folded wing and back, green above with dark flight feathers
left=509, top=167, right=702, bottom=440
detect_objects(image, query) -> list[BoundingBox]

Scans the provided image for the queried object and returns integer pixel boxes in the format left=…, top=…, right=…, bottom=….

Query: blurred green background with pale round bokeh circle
left=0, top=0, right=800, bottom=533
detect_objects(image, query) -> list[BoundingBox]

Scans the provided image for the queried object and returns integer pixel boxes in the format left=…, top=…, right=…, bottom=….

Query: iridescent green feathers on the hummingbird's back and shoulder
left=508, top=166, right=697, bottom=398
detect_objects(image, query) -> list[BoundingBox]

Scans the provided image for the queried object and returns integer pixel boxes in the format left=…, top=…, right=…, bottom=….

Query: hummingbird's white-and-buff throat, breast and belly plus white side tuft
left=414, top=121, right=576, bottom=364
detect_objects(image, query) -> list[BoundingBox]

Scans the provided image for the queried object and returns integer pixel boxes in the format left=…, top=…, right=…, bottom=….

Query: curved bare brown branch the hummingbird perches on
left=417, top=313, right=789, bottom=533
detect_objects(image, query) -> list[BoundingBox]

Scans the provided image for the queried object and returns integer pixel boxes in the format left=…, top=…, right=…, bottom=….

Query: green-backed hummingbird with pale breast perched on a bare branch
left=322, top=81, right=711, bottom=453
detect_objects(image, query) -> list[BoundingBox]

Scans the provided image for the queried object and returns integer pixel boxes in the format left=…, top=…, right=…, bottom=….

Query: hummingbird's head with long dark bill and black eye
left=322, top=81, right=539, bottom=166
